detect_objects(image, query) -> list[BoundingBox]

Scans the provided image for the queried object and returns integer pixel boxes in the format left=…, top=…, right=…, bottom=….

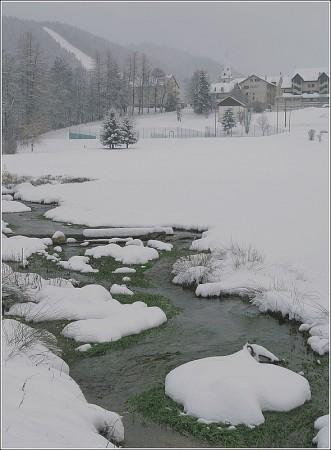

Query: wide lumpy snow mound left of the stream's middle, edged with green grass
left=7, top=283, right=167, bottom=342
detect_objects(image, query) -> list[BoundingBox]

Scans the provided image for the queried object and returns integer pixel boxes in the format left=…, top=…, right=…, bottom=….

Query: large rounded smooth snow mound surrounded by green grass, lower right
left=165, top=346, right=311, bottom=426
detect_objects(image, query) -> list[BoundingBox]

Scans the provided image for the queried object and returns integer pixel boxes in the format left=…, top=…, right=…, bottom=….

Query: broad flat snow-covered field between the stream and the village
left=3, top=108, right=329, bottom=446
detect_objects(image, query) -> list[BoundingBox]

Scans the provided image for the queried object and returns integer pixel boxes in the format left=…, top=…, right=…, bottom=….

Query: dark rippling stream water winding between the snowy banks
left=4, top=205, right=330, bottom=448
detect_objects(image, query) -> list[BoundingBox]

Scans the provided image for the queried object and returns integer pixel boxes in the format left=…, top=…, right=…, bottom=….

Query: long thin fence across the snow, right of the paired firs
left=138, top=125, right=287, bottom=139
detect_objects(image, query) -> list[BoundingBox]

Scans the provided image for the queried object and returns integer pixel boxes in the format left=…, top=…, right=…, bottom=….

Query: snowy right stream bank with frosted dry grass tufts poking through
left=172, top=246, right=329, bottom=355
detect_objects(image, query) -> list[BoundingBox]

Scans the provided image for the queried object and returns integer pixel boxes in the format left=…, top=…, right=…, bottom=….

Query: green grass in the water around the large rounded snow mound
left=126, top=356, right=329, bottom=448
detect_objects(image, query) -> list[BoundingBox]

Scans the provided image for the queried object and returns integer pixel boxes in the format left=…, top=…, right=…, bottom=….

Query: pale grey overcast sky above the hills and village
left=1, top=1, right=330, bottom=75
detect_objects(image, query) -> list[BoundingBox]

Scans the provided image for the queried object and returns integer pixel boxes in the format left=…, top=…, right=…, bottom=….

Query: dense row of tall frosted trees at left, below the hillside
left=2, top=31, right=178, bottom=153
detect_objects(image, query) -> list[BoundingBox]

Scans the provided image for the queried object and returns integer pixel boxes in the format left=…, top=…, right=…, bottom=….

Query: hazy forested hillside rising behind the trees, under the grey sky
left=2, top=16, right=236, bottom=87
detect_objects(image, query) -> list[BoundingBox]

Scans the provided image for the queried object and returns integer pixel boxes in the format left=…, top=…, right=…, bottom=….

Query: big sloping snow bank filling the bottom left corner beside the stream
left=2, top=319, right=124, bottom=448
